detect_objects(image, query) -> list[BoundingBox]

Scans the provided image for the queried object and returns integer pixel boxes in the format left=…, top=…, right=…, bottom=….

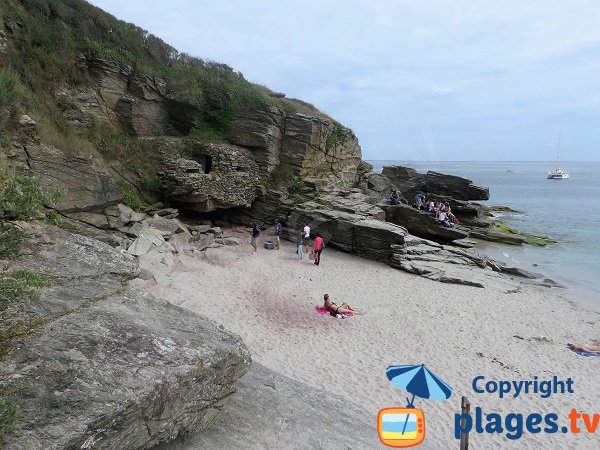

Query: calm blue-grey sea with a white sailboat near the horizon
left=369, top=161, right=600, bottom=304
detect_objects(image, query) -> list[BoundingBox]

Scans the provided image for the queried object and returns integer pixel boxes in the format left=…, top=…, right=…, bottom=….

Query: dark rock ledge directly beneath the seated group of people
left=379, top=205, right=469, bottom=242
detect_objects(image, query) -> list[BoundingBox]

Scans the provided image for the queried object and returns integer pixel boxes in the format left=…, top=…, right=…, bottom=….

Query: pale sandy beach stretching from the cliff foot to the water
left=136, top=230, right=600, bottom=449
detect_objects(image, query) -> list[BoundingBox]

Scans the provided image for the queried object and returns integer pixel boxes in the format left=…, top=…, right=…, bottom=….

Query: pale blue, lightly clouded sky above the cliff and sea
left=85, top=0, right=600, bottom=161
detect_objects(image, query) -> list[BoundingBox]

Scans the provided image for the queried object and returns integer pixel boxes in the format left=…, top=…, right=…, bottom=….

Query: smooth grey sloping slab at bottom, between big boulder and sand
left=153, top=363, right=380, bottom=450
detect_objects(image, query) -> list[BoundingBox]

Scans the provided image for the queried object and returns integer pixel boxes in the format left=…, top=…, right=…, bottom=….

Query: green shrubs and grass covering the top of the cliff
left=0, top=0, right=273, bottom=162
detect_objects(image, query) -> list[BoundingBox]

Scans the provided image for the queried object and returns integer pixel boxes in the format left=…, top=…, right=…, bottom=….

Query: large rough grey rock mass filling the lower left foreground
left=0, top=224, right=250, bottom=450
